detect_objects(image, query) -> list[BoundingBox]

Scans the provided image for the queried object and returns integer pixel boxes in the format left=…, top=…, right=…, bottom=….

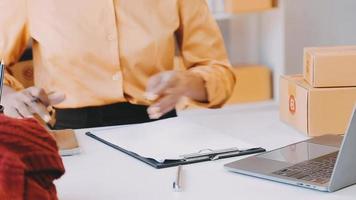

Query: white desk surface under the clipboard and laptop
left=56, top=102, right=356, bottom=200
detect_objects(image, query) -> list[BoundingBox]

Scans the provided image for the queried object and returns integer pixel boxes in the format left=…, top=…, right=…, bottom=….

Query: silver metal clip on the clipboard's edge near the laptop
left=180, top=147, right=266, bottom=161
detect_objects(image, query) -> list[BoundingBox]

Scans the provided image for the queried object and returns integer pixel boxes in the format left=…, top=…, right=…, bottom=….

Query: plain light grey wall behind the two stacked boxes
left=283, top=0, right=356, bottom=74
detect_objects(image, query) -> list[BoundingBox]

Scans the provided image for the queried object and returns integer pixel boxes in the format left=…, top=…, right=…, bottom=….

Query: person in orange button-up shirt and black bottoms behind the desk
left=0, top=0, right=235, bottom=128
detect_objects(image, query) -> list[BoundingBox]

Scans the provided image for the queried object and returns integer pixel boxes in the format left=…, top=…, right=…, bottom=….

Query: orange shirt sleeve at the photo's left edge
left=0, top=0, right=30, bottom=90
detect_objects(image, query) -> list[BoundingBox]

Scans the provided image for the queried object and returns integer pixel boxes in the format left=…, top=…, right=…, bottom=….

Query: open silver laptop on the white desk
left=225, top=108, right=356, bottom=192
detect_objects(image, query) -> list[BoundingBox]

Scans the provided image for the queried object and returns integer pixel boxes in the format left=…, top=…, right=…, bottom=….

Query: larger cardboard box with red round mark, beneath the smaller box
left=280, top=75, right=356, bottom=136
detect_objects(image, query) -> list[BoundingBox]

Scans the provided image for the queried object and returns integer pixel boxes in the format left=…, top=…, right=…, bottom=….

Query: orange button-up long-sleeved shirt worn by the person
left=0, top=0, right=235, bottom=108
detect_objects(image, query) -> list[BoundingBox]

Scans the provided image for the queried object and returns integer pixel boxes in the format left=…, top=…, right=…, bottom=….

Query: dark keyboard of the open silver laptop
left=273, top=152, right=338, bottom=184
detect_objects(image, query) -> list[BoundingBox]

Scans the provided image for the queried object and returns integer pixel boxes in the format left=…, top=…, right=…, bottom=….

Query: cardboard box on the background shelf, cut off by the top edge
left=225, top=0, right=278, bottom=13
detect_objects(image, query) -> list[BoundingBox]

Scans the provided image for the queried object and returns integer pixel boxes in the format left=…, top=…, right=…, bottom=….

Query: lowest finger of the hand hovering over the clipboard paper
left=147, top=95, right=179, bottom=119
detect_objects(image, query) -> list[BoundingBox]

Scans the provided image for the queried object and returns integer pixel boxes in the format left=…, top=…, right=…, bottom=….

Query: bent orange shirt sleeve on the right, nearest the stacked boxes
left=176, top=0, right=236, bottom=108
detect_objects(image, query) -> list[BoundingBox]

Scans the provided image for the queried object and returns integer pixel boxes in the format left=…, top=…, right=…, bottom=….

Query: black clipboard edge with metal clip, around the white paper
left=85, top=132, right=266, bottom=169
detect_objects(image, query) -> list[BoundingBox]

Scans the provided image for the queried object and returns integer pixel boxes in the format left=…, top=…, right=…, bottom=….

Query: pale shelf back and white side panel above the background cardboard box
left=216, top=8, right=284, bottom=99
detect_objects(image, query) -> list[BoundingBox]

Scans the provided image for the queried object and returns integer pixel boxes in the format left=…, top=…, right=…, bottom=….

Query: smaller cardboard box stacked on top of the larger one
left=303, top=46, right=356, bottom=87
